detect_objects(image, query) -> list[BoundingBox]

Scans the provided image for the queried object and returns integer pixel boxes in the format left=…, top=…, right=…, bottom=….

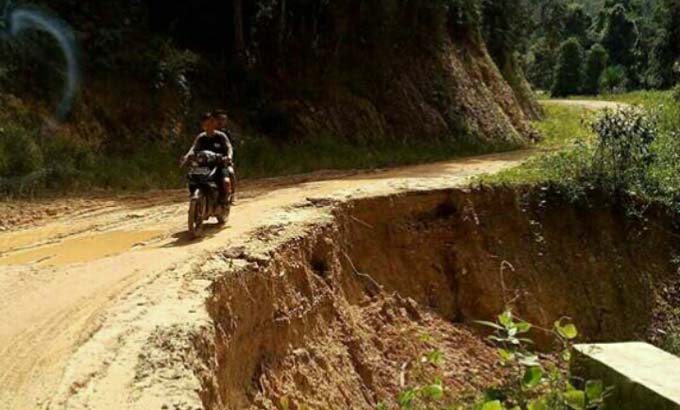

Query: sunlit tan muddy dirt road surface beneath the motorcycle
left=0, top=151, right=530, bottom=410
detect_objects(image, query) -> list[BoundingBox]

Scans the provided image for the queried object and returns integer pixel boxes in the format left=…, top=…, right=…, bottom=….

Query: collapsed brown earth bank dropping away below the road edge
left=193, top=190, right=677, bottom=409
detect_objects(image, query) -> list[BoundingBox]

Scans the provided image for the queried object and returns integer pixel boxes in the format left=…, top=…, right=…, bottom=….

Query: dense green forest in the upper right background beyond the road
left=518, top=0, right=680, bottom=96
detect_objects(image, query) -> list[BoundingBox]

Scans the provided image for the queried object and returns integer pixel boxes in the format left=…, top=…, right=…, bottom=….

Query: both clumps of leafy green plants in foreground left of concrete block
left=377, top=310, right=607, bottom=410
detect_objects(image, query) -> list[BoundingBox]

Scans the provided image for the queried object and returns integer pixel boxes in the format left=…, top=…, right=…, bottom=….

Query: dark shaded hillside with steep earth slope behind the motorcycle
left=0, top=0, right=541, bottom=192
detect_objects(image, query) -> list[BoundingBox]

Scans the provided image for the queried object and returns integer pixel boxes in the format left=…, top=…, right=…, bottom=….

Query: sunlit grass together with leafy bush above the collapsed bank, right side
left=483, top=91, right=680, bottom=204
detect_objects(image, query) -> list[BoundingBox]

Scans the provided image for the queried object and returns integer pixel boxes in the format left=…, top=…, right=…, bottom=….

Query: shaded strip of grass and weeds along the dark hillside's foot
left=0, top=94, right=518, bottom=196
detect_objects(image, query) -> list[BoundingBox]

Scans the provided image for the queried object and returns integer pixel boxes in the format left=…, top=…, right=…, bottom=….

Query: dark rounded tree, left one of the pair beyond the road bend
left=551, top=37, right=583, bottom=97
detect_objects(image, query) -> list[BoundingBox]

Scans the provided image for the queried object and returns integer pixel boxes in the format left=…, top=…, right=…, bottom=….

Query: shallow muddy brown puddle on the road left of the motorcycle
left=0, top=231, right=163, bottom=266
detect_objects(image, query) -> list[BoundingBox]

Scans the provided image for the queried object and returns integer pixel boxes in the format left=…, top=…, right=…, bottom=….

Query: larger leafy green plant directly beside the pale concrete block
left=474, top=310, right=605, bottom=410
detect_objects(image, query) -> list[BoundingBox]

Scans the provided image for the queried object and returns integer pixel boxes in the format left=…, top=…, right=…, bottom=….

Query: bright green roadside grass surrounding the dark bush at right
left=476, top=91, right=680, bottom=204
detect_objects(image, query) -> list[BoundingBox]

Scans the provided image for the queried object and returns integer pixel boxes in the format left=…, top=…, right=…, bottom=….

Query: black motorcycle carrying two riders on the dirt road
left=187, top=151, right=231, bottom=238
